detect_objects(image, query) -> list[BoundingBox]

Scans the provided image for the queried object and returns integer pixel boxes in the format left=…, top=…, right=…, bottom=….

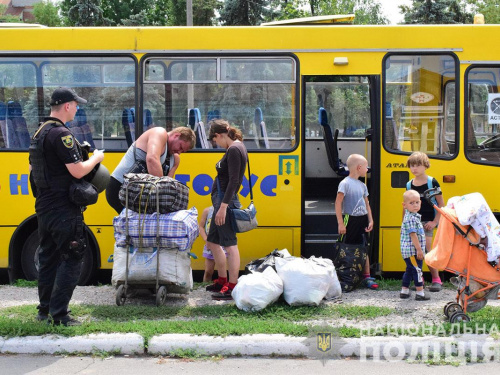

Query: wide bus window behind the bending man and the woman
left=143, top=57, right=296, bottom=150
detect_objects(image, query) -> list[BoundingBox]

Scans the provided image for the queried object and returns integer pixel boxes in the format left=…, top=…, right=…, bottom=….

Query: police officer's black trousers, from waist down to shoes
left=37, top=207, right=83, bottom=321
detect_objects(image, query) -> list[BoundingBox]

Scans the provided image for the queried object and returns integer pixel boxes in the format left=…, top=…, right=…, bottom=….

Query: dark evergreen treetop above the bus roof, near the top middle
left=220, top=0, right=270, bottom=26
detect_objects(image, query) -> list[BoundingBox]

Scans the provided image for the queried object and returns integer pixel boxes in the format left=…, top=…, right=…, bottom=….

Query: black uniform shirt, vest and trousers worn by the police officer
left=30, top=117, right=85, bottom=322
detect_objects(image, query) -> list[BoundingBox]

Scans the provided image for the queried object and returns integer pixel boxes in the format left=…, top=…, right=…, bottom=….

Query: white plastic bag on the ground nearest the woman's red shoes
left=231, top=267, right=283, bottom=311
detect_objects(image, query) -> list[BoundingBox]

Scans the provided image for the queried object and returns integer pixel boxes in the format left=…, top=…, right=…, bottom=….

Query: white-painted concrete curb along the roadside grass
left=0, top=333, right=500, bottom=361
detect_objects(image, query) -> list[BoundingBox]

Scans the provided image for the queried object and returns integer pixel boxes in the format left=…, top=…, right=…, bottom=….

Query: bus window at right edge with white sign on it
left=465, top=67, right=500, bottom=164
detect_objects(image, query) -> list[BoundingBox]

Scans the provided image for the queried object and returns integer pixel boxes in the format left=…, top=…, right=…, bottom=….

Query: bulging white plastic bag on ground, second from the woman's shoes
left=276, top=257, right=332, bottom=306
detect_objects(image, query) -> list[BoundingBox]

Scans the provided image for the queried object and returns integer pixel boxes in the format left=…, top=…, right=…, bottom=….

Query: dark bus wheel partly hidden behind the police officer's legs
left=21, top=231, right=94, bottom=285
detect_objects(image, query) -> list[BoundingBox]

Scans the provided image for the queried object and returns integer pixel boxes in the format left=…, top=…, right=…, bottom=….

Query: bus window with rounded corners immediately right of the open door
left=383, top=54, right=458, bottom=157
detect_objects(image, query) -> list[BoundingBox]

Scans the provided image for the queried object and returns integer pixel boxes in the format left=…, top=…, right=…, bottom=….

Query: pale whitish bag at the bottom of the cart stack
left=111, top=245, right=193, bottom=293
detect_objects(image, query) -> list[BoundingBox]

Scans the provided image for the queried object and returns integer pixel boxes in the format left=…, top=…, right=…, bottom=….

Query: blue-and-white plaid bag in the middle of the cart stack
left=113, top=207, right=199, bottom=251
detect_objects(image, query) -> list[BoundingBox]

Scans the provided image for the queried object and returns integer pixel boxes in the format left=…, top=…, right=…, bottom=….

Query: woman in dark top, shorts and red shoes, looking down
left=207, top=119, right=248, bottom=300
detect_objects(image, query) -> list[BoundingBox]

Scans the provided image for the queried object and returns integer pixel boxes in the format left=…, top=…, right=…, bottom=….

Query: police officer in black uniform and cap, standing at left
left=30, top=87, right=104, bottom=326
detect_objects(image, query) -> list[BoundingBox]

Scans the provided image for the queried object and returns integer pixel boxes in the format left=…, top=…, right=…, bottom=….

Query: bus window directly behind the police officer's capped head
left=40, top=57, right=136, bottom=150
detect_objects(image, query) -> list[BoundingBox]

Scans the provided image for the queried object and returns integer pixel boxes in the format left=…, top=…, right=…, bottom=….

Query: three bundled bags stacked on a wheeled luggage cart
left=112, top=173, right=199, bottom=306
